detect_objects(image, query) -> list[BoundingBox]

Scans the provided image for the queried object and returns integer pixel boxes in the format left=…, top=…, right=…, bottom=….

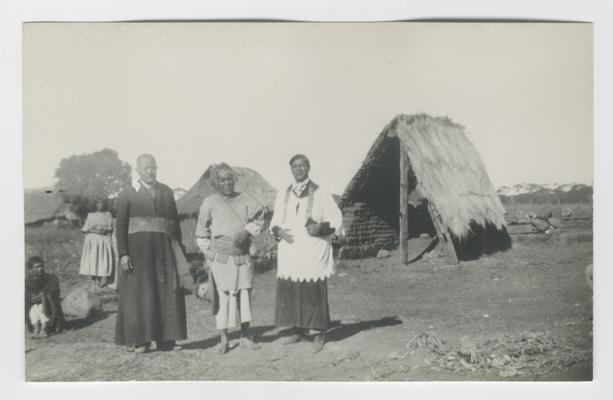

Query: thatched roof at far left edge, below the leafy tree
left=24, top=188, right=68, bottom=225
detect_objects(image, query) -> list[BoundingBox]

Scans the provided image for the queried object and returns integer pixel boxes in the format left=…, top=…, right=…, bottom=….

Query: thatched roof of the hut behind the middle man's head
left=177, top=165, right=277, bottom=217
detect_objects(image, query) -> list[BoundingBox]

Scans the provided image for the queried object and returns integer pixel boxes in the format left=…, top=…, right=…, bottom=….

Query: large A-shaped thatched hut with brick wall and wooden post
left=340, top=114, right=510, bottom=262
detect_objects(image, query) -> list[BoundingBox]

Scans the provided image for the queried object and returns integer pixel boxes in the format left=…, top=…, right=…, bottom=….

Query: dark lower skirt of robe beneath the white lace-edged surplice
left=275, top=279, right=330, bottom=330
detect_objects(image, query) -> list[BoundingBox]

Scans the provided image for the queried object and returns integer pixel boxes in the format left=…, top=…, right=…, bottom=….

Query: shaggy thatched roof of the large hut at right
left=341, top=114, right=506, bottom=238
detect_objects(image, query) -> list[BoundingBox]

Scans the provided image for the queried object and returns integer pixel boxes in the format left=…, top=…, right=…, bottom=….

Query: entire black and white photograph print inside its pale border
left=19, top=21, right=594, bottom=382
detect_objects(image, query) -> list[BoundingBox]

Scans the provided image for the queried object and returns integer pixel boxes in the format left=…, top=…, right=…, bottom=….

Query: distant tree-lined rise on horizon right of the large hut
left=497, top=183, right=593, bottom=204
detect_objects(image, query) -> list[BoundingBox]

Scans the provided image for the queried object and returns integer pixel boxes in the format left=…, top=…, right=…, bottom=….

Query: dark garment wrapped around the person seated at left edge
left=25, top=272, right=66, bottom=333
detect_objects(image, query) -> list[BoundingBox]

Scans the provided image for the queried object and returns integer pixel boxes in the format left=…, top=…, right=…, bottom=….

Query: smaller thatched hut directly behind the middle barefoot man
left=177, top=165, right=277, bottom=254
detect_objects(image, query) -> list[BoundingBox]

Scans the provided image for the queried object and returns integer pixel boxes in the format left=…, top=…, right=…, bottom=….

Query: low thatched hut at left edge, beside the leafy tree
left=24, top=188, right=79, bottom=226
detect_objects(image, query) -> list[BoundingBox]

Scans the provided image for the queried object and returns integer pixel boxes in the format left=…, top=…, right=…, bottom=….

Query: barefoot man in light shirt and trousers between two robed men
left=196, top=163, right=264, bottom=354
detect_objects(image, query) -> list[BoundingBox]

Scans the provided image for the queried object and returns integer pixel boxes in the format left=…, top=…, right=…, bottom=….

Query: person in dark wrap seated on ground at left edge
left=25, top=256, right=66, bottom=337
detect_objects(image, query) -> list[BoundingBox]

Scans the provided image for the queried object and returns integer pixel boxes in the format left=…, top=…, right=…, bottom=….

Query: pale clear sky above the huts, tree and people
left=23, top=22, right=593, bottom=194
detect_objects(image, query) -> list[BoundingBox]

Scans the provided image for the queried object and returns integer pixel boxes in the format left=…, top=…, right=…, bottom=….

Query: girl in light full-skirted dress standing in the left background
left=79, top=199, right=115, bottom=290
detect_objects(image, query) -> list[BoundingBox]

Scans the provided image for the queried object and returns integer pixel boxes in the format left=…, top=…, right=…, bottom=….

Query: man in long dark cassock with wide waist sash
left=115, top=154, right=187, bottom=353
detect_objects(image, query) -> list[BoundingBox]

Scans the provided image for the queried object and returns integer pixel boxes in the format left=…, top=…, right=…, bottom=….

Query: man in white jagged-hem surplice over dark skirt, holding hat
left=270, top=154, right=343, bottom=352
